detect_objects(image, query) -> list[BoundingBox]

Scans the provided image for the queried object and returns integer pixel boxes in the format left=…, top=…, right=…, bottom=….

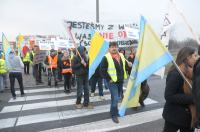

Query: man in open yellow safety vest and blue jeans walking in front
left=100, top=42, right=132, bottom=123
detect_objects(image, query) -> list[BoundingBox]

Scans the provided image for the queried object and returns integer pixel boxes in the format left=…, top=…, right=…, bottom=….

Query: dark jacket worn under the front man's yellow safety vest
left=100, top=56, right=128, bottom=82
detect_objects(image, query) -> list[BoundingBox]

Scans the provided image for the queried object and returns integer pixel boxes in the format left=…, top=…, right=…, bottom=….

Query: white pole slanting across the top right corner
left=170, top=0, right=200, bottom=45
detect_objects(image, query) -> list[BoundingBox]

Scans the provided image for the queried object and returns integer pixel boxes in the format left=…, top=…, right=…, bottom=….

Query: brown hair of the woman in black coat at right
left=169, top=46, right=196, bottom=71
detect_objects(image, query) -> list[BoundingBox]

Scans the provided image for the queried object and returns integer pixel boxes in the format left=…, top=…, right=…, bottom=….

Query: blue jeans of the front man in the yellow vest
left=107, top=81, right=123, bottom=117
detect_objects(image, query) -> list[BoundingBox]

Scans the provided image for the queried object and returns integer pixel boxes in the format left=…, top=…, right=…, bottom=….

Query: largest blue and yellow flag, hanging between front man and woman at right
left=119, top=17, right=173, bottom=116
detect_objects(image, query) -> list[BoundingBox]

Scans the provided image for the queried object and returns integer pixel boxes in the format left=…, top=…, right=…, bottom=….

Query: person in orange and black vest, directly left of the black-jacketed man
left=61, top=50, right=72, bottom=93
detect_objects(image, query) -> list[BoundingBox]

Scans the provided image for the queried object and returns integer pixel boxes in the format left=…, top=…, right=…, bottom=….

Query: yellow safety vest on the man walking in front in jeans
left=105, top=53, right=127, bottom=82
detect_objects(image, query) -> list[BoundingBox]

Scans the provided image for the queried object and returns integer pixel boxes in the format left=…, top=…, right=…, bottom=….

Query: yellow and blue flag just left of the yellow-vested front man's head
left=88, top=32, right=109, bottom=79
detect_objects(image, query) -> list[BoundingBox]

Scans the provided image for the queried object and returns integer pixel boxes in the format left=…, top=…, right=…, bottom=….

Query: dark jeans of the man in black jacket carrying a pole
left=76, top=75, right=89, bottom=106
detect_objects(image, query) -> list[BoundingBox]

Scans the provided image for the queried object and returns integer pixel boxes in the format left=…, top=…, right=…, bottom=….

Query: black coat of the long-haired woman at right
left=163, top=69, right=193, bottom=127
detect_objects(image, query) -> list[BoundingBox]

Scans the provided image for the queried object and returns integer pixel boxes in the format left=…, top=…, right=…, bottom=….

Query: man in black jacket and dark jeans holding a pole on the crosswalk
left=72, top=46, right=93, bottom=109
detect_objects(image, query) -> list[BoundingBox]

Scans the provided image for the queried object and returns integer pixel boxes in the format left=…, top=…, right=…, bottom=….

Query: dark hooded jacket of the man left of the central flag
left=72, top=46, right=89, bottom=76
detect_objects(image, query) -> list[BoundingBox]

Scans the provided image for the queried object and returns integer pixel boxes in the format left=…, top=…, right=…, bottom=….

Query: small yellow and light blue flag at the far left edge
left=2, top=33, right=11, bottom=66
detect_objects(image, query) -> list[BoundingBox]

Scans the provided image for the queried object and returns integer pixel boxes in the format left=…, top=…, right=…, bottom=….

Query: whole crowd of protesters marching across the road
left=0, top=42, right=200, bottom=132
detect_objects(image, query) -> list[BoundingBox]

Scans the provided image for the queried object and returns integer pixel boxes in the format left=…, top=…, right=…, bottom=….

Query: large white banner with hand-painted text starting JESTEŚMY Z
left=64, top=20, right=138, bottom=47
